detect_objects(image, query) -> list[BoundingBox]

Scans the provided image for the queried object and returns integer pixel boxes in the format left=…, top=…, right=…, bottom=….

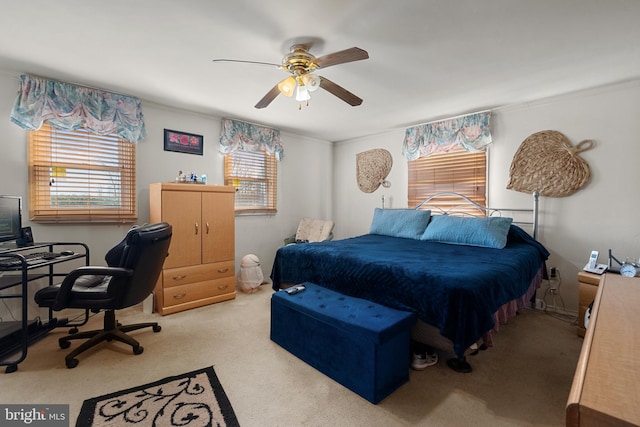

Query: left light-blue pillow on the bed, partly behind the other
left=369, top=208, right=431, bottom=240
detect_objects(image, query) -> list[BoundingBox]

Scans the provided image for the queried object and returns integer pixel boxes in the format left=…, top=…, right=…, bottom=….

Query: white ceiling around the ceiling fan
left=0, top=0, right=640, bottom=141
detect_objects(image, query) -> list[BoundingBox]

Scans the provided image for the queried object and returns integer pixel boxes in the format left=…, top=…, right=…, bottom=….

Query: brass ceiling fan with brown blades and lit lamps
left=213, top=44, right=369, bottom=108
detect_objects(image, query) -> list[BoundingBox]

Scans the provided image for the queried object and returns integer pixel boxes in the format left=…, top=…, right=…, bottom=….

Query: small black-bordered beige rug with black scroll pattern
left=76, top=367, right=239, bottom=427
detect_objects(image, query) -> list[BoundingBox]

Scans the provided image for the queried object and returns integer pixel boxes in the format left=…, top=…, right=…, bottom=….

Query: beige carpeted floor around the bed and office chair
left=0, top=286, right=582, bottom=427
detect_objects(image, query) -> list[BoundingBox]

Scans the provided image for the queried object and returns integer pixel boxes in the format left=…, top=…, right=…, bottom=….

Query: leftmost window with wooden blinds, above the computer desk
left=29, top=124, right=137, bottom=222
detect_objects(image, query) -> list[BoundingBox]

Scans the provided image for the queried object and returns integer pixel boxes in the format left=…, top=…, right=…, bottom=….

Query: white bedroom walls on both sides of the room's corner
left=0, top=67, right=640, bottom=317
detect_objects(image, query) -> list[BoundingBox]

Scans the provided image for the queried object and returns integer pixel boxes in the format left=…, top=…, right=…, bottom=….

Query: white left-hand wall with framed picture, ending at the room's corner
left=0, top=72, right=333, bottom=318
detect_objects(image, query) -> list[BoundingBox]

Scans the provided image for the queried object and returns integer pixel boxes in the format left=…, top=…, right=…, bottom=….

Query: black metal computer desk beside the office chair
left=0, top=242, right=90, bottom=373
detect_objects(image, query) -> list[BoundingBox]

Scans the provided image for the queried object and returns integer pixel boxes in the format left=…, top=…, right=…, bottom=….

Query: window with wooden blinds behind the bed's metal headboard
left=408, top=147, right=487, bottom=214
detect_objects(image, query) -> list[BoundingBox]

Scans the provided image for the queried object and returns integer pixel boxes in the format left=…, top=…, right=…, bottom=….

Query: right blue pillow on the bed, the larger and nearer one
left=421, top=215, right=513, bottom=249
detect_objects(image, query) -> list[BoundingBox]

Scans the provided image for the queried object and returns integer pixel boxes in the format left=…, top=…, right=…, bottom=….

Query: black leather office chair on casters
left=34, top=222, right=172, bottom=368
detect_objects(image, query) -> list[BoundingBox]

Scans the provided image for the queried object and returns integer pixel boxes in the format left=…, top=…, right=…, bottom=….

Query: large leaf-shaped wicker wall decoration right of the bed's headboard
left=507, top=130, right=594, bottom=197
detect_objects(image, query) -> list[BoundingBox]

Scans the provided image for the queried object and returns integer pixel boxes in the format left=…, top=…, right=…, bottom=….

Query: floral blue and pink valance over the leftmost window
left=11, top=74, right=146, bottom=142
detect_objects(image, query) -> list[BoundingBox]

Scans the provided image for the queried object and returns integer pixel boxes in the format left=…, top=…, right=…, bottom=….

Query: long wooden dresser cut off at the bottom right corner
left=566, top=273, right=640, bottom=426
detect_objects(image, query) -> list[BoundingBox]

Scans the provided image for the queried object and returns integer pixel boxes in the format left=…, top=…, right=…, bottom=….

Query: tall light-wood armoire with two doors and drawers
left=149, top=183, right=236, bottom=315
